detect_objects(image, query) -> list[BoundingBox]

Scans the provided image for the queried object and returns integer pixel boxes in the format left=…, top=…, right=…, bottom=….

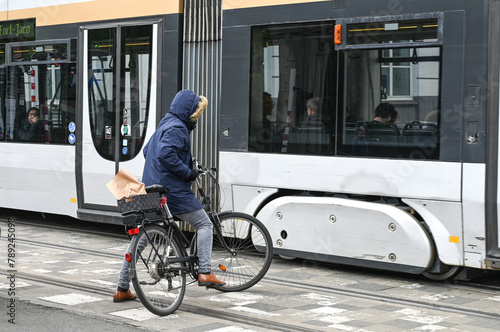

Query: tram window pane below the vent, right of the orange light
left=338, top=47, right=441, bottom=159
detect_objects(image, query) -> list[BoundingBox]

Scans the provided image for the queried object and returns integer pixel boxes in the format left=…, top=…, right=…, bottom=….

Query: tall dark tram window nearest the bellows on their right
left=249, top=22, right=336, bottom=155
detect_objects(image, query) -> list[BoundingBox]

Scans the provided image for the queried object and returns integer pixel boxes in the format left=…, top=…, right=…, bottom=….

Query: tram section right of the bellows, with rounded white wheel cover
left=219, top=0, right=500, bottom=279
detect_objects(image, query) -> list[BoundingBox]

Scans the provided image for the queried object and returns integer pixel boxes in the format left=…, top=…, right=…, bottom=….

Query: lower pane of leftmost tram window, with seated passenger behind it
left=5, top=63, right=76, bottom=144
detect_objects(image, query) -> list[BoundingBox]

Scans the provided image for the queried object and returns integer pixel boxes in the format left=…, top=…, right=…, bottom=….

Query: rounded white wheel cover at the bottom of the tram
left=257, top=196, right=434, bottom=273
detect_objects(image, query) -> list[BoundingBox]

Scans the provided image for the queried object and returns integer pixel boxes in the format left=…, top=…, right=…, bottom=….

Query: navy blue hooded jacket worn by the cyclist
left=142, top=90, right=203, bottom=215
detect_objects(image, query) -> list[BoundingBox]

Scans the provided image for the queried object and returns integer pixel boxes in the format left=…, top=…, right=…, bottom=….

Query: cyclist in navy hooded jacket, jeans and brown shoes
left=113, top=90, right=225, bottom=302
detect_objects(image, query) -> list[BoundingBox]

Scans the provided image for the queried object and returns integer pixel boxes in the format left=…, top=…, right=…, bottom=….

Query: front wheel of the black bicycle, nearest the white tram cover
left=212, top=212, right=273, bottom=292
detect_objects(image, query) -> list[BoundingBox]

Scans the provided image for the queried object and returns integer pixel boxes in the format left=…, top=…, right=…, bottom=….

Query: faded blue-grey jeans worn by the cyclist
left=118, top=209, right=213, bottom=291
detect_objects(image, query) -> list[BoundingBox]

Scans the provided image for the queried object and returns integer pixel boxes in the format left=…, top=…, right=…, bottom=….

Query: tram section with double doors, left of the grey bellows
left=0, top=0, right=188, bottom=222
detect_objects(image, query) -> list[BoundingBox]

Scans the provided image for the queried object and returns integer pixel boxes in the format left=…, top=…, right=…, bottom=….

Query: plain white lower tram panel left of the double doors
left=0, top=143, right=77, bottom=217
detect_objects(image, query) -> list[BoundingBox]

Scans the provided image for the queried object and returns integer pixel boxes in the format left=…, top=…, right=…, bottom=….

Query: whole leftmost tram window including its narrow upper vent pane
left=4, top=39, right=77, bottom=144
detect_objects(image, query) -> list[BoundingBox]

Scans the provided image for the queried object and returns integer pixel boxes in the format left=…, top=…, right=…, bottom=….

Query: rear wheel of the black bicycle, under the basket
left=130, top=224, right=186, bottom=316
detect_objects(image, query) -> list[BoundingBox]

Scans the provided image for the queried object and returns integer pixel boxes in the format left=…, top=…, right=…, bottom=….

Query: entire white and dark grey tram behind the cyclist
left=0, top=0, right=500, bottom=280
